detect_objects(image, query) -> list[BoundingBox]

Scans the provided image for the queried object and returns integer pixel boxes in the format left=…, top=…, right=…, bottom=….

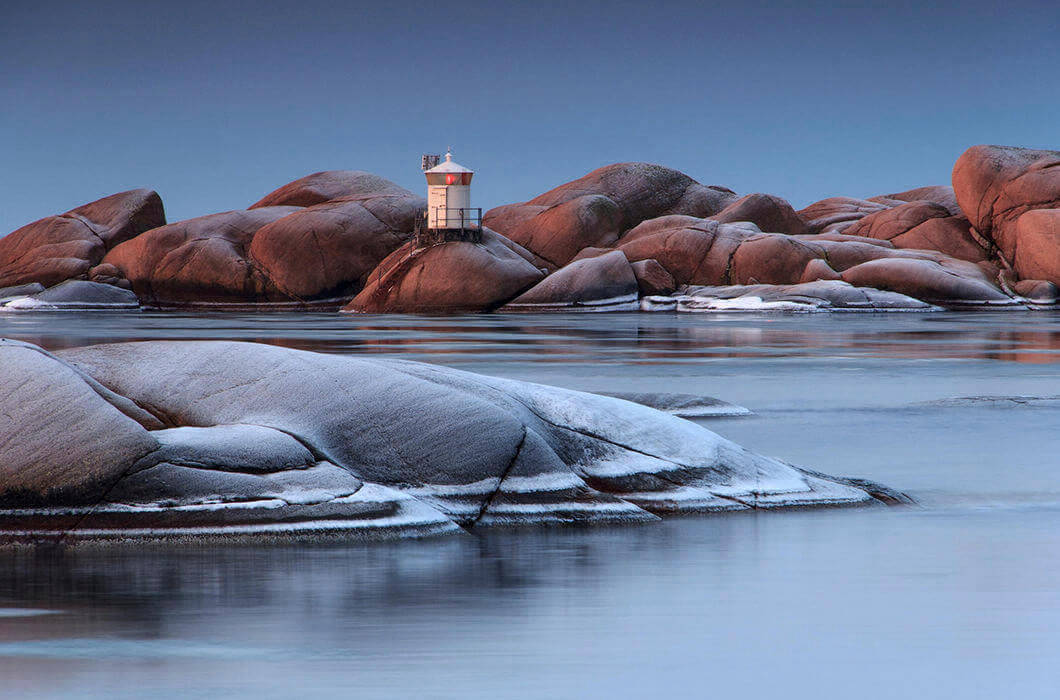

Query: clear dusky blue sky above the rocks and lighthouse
left=0, top=0, right=1060, bottom=233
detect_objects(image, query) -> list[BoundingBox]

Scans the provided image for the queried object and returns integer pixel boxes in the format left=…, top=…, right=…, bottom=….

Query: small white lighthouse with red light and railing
left=418, top=152, right=482, bottom=244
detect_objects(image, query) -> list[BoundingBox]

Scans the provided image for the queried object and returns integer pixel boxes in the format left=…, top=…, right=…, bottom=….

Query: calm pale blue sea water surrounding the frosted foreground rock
left=0, top=313, right=1060, bottom=698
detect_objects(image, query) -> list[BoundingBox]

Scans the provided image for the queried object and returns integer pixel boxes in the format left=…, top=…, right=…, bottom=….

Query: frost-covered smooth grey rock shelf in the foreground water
left=0, top=340, right=902, bottom=543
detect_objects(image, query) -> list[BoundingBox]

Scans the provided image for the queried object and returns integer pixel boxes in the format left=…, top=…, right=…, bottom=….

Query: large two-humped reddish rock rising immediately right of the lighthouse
left=483, top=162, right=736, bottom=268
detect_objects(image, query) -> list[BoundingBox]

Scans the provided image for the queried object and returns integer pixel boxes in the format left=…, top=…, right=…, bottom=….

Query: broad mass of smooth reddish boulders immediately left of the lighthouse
left=105, top=171, right=426, bottom=307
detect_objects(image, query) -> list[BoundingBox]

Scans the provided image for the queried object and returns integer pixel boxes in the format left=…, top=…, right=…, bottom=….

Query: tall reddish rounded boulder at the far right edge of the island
left=953, top=145, right=1060, bottom=282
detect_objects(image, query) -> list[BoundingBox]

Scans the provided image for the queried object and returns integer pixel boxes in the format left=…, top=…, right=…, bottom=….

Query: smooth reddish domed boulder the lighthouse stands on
left=342, top=228, right=545, bottom=313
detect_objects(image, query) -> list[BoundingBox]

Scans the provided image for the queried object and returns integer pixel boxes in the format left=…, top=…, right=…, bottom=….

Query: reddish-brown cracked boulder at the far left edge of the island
left=0, top=190, right=165, bottom=287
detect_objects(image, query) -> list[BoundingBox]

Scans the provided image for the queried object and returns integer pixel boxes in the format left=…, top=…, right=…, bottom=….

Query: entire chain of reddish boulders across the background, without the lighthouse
left=0, top=145, right=1060, bottom=313
